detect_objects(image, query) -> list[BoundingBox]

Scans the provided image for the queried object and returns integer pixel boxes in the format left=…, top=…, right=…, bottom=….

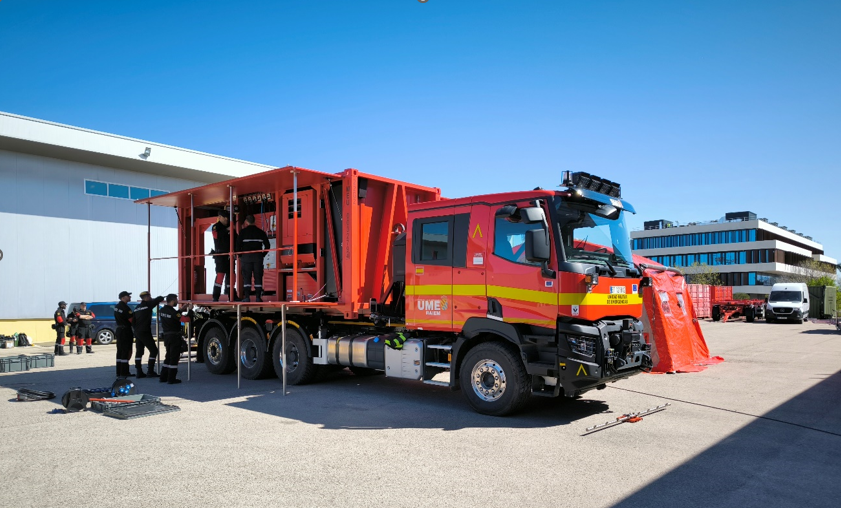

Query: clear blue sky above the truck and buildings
left=0, top=0, right=841, bottom=270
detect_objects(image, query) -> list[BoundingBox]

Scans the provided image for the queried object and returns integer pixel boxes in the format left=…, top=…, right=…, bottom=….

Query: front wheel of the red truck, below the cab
left=460, top=342, right=531, bottom=416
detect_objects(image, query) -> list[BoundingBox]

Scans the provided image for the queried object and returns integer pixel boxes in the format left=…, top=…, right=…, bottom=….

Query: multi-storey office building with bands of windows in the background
left=631, top=212, right=838, bottom=296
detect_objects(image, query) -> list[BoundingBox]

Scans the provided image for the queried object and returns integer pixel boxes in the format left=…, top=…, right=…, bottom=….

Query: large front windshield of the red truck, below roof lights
left=555, top=199, right=634, bottom=267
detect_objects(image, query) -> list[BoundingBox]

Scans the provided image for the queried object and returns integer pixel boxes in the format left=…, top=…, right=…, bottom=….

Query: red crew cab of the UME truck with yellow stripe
left=405, top=173, right=652, bottom=412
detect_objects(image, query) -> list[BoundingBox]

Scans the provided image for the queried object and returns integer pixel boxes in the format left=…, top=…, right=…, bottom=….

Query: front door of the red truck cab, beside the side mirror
left=486, top=203, right=558, bottom=329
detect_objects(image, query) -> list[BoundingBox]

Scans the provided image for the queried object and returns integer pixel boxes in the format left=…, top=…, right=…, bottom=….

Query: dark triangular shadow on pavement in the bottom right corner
left=615, top=372, right=841, bottom=508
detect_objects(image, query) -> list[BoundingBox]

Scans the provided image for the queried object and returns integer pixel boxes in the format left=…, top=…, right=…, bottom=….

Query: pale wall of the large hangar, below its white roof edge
left=0, top=150, right=208, bottom=319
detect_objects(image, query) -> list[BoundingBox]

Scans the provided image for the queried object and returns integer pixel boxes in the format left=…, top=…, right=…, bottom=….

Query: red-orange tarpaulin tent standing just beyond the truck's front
left=634, top=255, right=724, bottom=373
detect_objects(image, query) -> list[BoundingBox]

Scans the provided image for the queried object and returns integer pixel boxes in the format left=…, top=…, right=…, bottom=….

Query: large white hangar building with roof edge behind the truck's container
left=0, top=112, right=273, bottom=326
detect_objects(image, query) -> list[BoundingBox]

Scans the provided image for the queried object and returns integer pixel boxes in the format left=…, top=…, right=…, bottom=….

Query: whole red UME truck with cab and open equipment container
left=139, top=167, right=652, bottom=415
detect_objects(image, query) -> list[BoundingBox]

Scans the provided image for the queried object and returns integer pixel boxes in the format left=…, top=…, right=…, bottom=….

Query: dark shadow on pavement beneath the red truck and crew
left=0, top=362, right=610, bottom=430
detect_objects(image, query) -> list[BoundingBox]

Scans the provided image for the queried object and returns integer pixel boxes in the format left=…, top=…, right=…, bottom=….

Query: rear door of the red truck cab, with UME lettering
left=406, top=208, right=455, bottom=331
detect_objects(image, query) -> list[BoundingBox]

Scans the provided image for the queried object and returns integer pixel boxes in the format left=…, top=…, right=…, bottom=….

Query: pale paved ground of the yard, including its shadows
left=0, top=322, right=841, bottom=508
